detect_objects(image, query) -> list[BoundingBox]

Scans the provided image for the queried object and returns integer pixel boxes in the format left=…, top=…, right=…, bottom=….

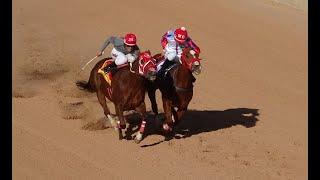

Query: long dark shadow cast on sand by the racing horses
left=141, top=108, right=259, bottom=147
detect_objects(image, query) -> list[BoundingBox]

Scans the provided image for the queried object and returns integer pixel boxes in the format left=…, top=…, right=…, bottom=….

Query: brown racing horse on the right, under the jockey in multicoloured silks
left=148, top=48, right=201, bottom=133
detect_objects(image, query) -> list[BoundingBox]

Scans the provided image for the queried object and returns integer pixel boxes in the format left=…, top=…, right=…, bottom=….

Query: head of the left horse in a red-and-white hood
left=138, top=50, right=157, bottom=81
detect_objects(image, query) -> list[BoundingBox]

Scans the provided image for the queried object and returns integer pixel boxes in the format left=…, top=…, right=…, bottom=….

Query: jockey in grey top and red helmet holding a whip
left=97, top=33, right=140, bottom=73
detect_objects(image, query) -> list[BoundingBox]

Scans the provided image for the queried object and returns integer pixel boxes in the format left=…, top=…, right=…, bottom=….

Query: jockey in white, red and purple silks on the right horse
left=158, top=27, right=200, bottom=74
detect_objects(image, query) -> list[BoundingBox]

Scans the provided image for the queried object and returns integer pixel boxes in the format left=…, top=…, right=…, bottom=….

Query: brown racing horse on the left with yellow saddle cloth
left=77, top=50, right=156, bottom=143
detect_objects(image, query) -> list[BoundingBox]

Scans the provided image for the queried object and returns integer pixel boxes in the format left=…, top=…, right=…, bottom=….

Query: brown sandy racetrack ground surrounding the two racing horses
left=12, top=0, right=308, bottom=180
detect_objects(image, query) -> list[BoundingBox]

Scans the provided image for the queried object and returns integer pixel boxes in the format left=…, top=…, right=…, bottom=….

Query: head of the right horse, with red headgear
left=181, top=48, right=201, bottom=75
